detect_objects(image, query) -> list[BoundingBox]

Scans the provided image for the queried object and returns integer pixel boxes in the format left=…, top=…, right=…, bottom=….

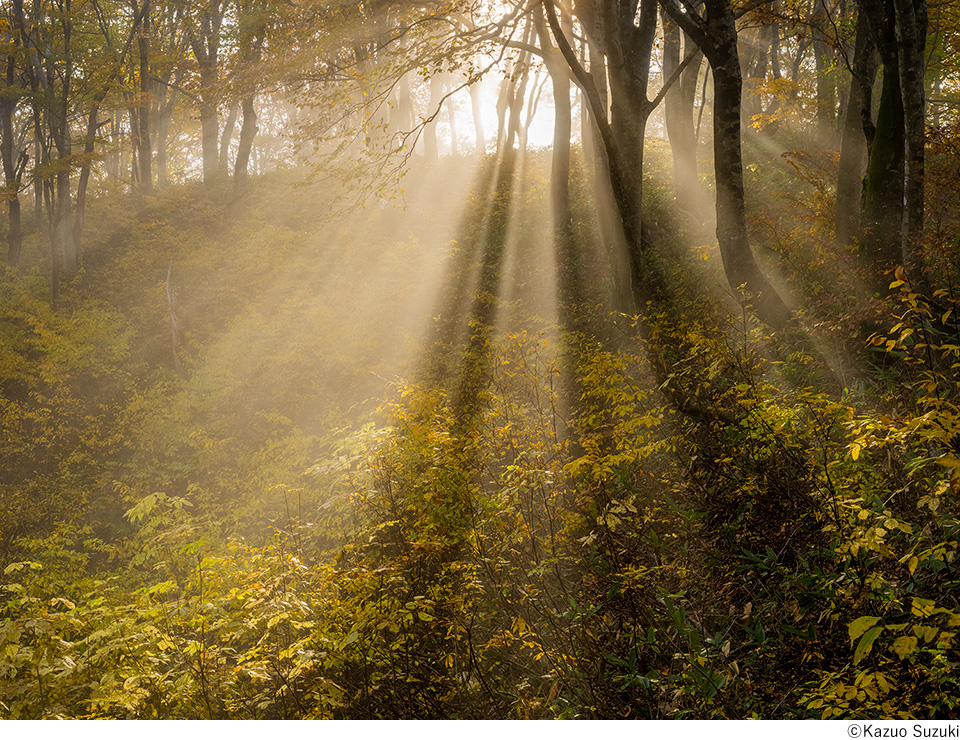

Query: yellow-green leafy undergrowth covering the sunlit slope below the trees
left=0, top=156, right=960, bottom=719
